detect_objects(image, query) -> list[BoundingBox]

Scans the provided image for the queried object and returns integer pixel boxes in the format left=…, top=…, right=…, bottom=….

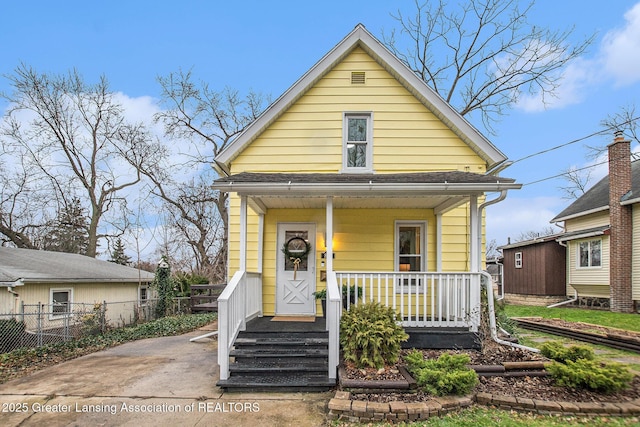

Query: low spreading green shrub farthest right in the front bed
left=546, top=359, right=633, bottom=393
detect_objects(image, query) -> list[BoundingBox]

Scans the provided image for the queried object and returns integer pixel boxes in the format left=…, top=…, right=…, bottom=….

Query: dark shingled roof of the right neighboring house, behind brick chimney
left=550, top=160, right=640, bottom=222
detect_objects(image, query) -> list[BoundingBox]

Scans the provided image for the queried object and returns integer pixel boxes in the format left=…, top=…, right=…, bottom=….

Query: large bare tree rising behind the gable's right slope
left=384, top=0, right=593, bottom=133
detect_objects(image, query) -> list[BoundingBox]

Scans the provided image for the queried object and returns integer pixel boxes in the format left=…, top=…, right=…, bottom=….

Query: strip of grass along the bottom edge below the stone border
left=333, top=407, right=640, bottom=427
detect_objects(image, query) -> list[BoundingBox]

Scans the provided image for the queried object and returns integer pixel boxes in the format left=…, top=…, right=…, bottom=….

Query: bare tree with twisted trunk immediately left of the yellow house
left=148, top=71, right=269, bottom=280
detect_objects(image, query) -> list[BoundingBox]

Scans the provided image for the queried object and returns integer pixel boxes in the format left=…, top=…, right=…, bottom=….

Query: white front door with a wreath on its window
left=276, top=223, right=316, bottom=315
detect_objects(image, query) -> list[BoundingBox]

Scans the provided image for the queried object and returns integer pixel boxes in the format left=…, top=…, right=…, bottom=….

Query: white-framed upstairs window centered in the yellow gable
left=342, top=113, right=373, bottom=172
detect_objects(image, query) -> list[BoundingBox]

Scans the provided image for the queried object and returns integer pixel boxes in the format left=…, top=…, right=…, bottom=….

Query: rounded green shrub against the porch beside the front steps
left=340, top=302, right=409, bottom=369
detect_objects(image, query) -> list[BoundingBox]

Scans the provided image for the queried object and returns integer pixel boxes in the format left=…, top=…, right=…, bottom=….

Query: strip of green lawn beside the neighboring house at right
left=504, top=304, right=640, bottom=332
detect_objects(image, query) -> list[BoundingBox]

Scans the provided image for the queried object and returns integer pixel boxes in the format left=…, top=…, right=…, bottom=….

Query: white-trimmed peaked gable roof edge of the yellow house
left=215, top=24, right=507, bottom=174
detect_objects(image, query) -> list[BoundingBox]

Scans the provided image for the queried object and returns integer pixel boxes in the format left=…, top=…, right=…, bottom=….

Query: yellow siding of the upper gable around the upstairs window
left=231, top=48, right=486, bottom=174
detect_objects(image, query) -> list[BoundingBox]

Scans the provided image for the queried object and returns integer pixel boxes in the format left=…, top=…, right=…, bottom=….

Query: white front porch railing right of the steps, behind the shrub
left=336, top=272, right=482, bottom=332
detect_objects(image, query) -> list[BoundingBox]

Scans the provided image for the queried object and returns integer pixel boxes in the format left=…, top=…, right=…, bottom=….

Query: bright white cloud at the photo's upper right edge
left=601, top=3, right=640, bottom=86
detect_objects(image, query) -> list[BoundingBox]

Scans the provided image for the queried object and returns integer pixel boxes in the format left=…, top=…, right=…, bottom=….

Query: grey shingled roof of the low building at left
left=0, top=247, right=154, bottom=286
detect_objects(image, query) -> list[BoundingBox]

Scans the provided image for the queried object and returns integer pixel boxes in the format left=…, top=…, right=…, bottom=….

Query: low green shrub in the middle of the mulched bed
left=405, top=350, right=478, bottom=396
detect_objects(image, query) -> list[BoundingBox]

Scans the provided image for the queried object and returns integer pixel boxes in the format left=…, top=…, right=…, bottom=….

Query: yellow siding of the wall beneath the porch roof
left=230, top=209, right=476, bottom=316
